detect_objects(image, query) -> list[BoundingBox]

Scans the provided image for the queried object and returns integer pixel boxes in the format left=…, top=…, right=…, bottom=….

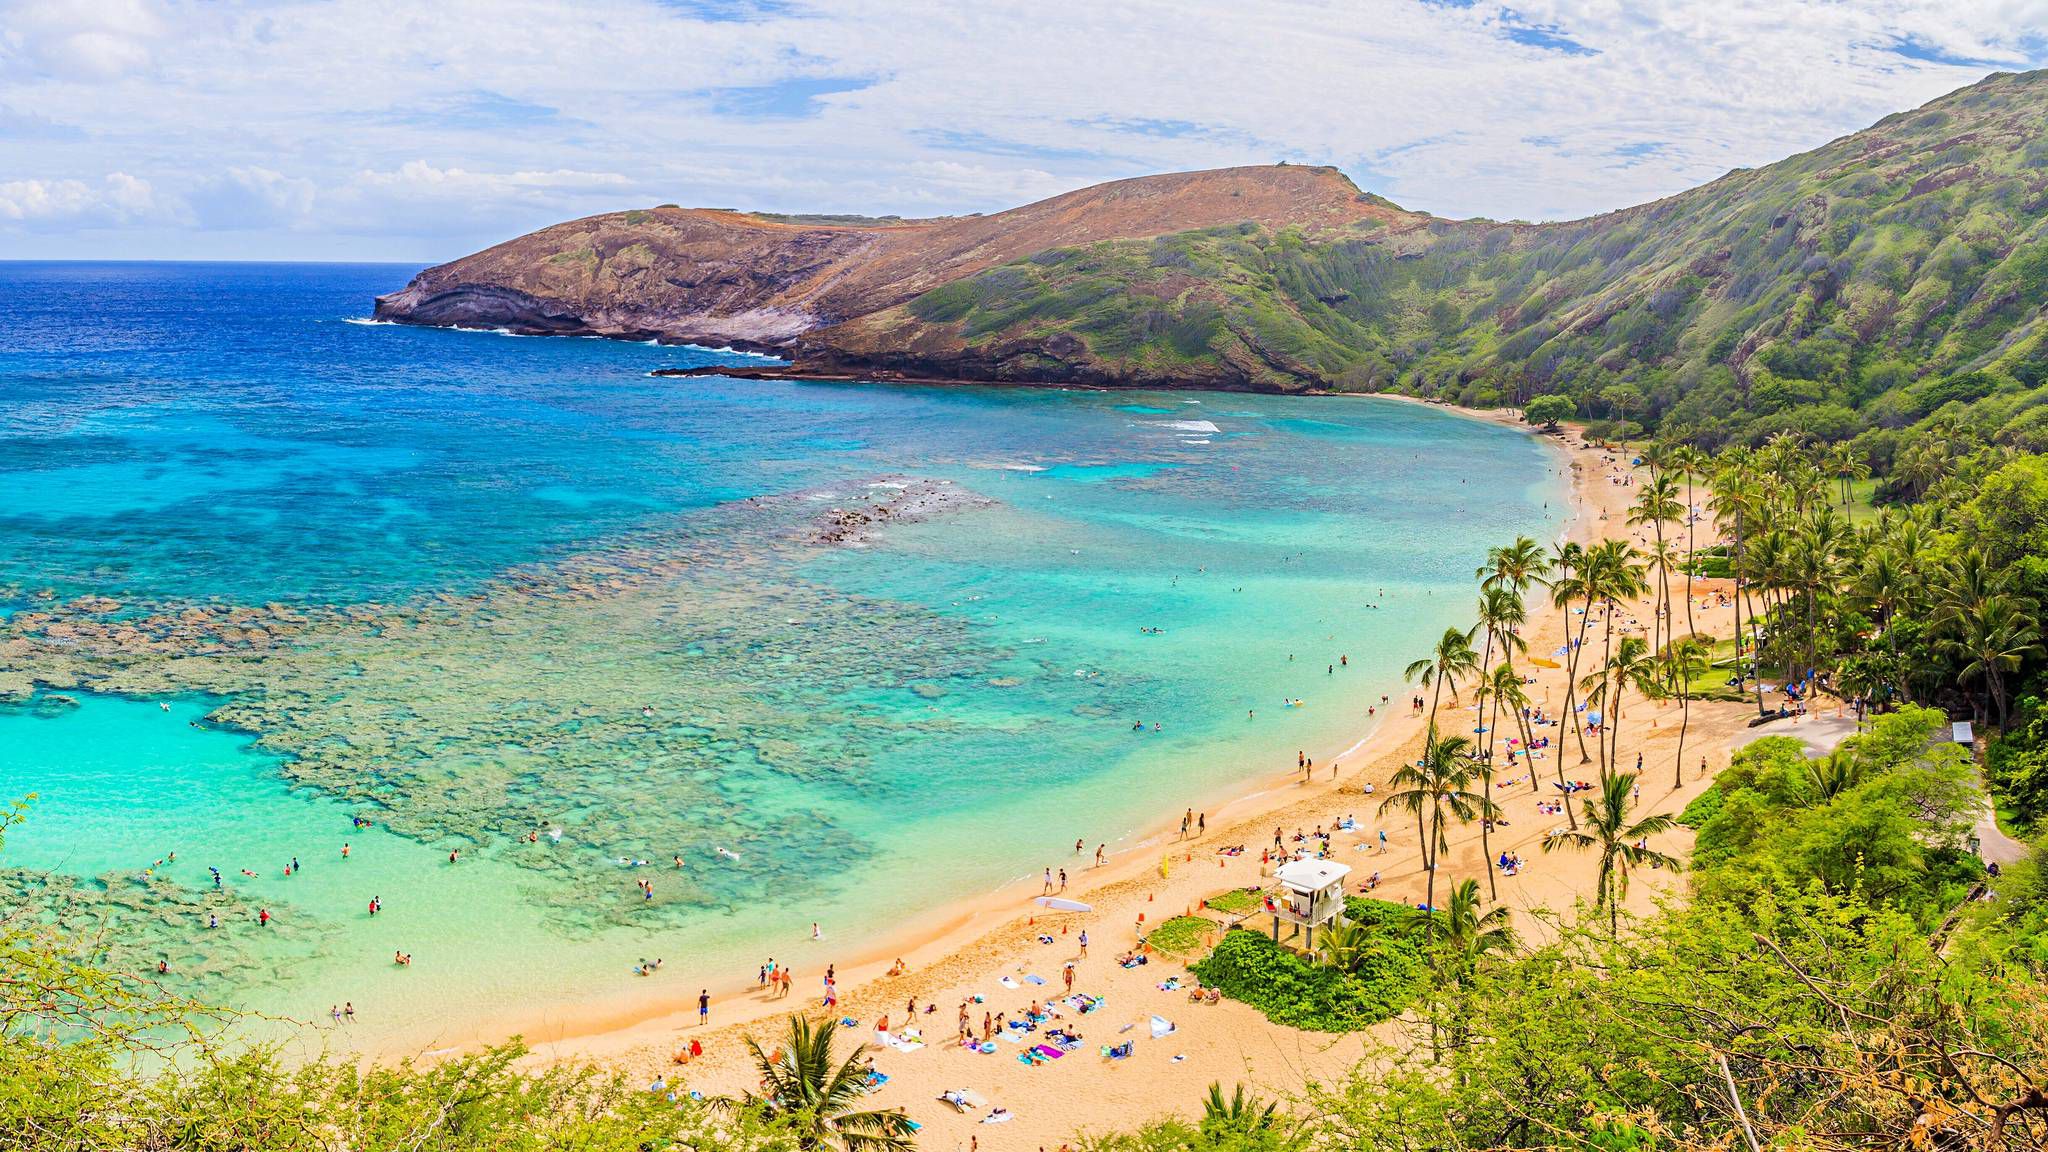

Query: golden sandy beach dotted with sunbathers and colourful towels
left=479, top=414, right=1837, bottom=1148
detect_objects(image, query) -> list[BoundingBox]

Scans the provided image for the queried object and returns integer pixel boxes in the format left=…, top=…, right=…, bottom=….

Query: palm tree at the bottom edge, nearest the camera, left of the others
left=715, top=1015, right=918, bottom=1152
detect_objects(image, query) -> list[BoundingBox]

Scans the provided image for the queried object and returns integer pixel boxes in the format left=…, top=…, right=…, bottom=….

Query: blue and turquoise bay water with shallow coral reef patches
left=0, top=264, right=1563, bottom=1043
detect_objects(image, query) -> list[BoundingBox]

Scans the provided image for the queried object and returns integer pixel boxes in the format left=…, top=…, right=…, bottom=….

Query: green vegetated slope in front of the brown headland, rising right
left=799, top=72, right=2048, bottom=414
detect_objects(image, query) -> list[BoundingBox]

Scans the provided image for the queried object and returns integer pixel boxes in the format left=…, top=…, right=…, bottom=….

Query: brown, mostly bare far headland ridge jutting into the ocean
left=377, top=166, right=1421, bottom=344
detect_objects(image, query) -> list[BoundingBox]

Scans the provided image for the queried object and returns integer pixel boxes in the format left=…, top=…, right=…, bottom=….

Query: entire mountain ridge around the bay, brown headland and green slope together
left=379, top=72, right=2048, bottom=434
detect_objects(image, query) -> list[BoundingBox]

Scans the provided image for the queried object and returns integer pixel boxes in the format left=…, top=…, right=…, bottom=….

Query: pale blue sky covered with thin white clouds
left=0, top=0, right=2048, bottom=260
